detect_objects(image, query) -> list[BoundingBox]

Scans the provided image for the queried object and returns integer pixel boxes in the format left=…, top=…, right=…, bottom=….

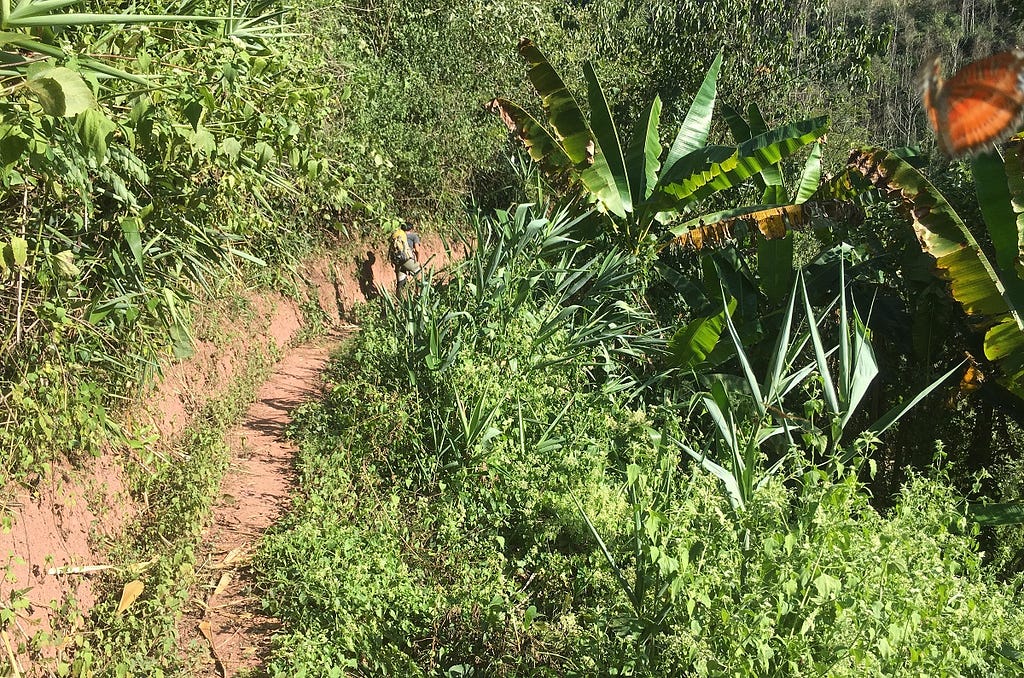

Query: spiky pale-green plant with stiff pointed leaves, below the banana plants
left=677, top=265, right=963, bottom=514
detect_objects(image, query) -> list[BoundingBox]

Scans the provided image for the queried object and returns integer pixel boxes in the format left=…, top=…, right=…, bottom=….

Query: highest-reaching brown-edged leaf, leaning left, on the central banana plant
left=519, top=40, right=594, bottom=165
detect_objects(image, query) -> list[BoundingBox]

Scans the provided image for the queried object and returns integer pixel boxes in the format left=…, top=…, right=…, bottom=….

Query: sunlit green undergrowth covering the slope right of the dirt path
left=254, top=209, right=1024, bottom=677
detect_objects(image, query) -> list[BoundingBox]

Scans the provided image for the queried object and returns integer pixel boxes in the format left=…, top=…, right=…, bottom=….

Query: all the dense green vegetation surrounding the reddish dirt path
left=6, top=0, right=1024, bottom=676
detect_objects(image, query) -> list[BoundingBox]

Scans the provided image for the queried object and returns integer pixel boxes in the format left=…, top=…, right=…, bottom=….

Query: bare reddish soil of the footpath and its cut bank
left=0, top=232, right=447, bottom=676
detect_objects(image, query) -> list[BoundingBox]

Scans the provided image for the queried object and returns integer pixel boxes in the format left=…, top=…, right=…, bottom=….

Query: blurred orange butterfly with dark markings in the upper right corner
left=922, top=49, right=1024, bottom=158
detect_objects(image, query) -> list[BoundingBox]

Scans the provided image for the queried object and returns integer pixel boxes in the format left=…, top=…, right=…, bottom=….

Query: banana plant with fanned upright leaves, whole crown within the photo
left=488, top=40, right=828, bottom=254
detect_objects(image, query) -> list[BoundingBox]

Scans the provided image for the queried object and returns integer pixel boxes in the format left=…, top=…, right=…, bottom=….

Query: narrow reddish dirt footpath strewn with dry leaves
left=179, top=335, right=342, bottom=676
